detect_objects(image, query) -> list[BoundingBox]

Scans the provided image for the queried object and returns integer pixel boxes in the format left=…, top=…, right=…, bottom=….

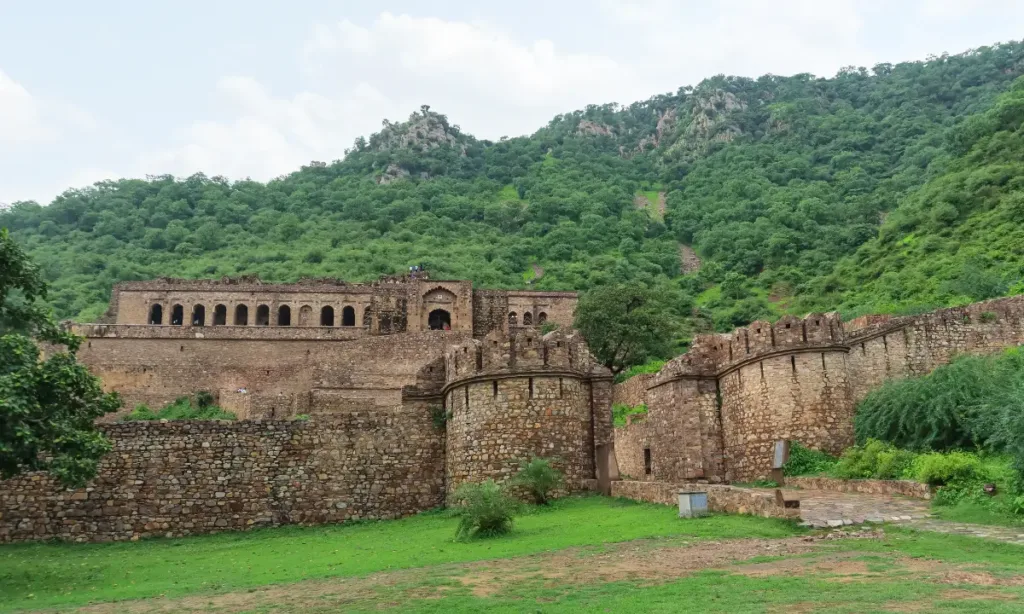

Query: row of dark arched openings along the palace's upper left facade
left=150, top=303, right=372, bottom=326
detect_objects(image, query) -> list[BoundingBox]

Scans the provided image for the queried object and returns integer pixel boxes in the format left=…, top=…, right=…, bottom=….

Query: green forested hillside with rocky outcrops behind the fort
left=0, top=43, right=1024, bottom=345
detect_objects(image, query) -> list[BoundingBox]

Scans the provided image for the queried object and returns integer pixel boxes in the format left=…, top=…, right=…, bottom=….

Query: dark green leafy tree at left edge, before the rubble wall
left=0, top=228, right=121, bottom=485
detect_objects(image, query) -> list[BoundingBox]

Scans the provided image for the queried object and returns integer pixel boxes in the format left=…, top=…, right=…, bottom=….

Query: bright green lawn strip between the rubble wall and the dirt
left=0, top=496, right=798, bottom=611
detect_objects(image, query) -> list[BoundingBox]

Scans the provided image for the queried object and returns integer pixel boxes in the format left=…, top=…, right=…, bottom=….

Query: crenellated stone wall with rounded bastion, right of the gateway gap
left=614, top=297, right=1024, bottom=483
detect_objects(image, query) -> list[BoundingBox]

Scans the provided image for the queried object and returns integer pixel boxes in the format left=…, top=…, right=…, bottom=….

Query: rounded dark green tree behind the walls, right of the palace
left=573, top=284, right=675, bottom=375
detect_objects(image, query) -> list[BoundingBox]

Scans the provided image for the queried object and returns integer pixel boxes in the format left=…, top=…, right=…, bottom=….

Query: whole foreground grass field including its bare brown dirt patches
left=0, top=496, right=1024, bottom=614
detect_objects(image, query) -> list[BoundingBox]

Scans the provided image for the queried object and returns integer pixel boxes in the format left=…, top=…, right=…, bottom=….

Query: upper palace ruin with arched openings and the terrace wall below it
left=76, top=276, right=575, bottom=420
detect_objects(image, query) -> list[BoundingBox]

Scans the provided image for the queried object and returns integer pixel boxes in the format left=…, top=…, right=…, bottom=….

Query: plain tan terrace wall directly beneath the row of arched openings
left=79, top=326, right=468, bottom=421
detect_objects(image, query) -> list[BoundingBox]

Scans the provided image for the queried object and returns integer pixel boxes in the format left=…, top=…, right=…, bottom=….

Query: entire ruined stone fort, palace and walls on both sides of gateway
left=0, top=273, right=1024, bottom=541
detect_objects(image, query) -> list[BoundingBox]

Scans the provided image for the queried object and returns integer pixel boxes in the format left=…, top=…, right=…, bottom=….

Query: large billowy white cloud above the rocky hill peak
left=145, top=12, right=646, bottom=179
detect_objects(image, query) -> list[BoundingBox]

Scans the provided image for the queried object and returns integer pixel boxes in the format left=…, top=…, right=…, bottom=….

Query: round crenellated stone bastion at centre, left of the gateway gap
left=443, top=328, right=611, bottom=493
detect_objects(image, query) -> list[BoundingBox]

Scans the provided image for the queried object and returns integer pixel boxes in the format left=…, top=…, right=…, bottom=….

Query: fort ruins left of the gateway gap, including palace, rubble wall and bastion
left=0, top=276, right=611, bottom=541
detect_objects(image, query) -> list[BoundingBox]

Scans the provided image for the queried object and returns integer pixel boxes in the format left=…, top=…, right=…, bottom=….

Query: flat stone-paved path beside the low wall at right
left=782, top=488, right=930, bottom=527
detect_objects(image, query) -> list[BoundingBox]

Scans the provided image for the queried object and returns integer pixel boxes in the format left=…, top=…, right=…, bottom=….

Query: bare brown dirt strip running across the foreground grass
left=66, top=534, right=1024, bottom=614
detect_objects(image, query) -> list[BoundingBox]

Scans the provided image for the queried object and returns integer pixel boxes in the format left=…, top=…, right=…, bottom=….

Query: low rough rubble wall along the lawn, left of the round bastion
left=0, top=413, right=444, bottom=541
